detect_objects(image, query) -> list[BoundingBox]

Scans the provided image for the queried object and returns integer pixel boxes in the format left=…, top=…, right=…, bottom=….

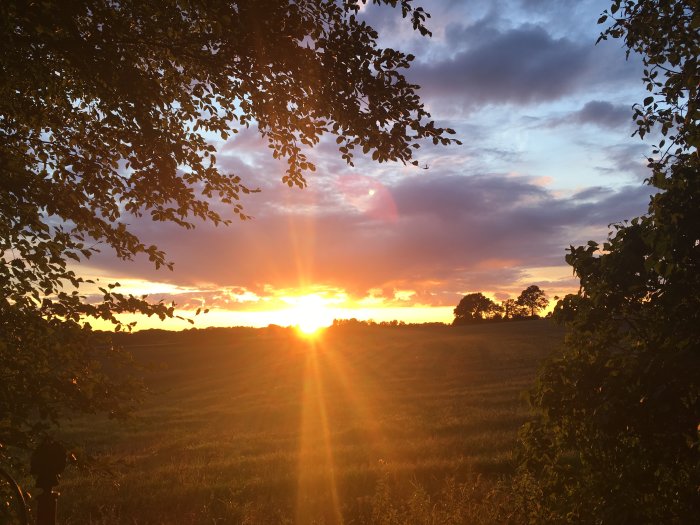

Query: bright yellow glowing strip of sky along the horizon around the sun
left=76, top=267, right=576, bottom=333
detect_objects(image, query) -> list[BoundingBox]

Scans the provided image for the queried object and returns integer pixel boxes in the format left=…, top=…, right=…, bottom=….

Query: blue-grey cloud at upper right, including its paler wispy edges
left=407, top=10, right=641, bottom=113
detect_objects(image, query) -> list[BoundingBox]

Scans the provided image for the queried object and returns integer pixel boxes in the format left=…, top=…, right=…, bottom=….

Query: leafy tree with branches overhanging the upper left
left=0, top=0, right=456, bottom=466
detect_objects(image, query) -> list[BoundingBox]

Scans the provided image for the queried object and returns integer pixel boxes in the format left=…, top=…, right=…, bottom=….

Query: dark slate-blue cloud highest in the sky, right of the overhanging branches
left=410, top=25, right=592, bottom=106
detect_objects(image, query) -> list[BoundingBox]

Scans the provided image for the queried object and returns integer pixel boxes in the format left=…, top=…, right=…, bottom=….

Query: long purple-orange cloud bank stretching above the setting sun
left=89, top=174, right=648, bottom=304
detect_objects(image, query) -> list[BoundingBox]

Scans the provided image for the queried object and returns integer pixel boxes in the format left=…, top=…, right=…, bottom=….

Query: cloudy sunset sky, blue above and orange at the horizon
left=81, top=0, right=651, bottom=329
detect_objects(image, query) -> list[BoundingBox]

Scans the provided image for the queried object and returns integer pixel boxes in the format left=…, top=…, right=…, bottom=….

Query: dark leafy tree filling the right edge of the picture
left=516, top=0, right=700, bottom=523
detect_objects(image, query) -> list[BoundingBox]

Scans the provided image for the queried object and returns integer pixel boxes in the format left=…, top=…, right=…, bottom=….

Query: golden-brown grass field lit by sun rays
left=59, top=321, right=562, bottom=525
